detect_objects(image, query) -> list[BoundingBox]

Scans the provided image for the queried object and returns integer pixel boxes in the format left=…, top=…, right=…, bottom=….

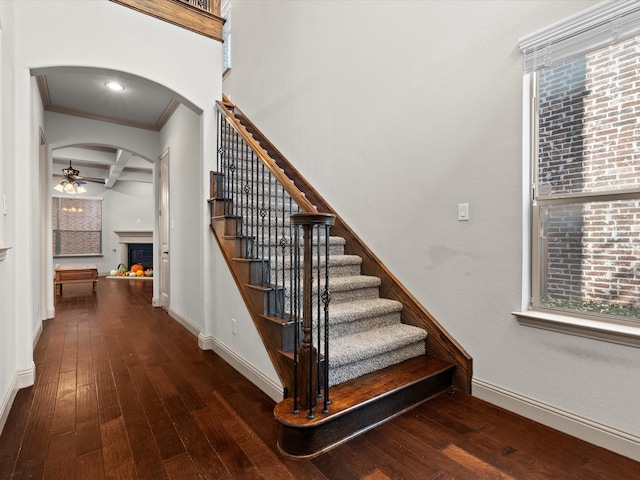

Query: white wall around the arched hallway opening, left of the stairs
left=0, top=0, right=222, bottom=436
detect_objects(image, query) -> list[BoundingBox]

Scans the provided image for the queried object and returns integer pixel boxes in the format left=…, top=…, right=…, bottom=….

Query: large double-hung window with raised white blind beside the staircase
left=520, top=1, right=640, bottom=343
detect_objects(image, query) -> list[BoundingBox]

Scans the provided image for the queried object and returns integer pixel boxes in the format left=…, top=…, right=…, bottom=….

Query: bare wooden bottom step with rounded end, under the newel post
left=274, top=355, right=455, bottom=458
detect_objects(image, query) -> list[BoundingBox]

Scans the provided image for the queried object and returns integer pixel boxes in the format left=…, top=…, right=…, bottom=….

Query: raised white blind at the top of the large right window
left=519, top=0, right=640, bottom=73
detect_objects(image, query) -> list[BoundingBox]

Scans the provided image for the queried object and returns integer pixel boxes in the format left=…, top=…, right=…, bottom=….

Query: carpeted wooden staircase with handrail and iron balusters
left=209, top=101, right=471, bottom=458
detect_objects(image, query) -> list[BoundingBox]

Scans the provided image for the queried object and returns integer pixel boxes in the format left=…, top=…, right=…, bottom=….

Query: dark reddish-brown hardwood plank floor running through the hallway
left=0, top=278, right=640, bottom=480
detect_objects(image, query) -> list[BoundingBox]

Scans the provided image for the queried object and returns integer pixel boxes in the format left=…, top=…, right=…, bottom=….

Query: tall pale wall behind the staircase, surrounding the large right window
left=224, top=0, right=640, bottom=455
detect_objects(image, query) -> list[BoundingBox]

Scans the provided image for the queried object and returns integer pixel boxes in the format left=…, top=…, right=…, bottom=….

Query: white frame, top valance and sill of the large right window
left=512, top=0, right=640, bottom=347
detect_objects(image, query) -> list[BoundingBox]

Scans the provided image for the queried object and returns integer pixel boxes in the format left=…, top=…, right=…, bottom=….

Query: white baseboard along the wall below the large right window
left=472, top=379, right=640, bottom=461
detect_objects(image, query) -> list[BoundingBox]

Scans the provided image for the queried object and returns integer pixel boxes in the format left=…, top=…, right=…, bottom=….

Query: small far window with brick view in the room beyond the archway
left=51, top=197, right=102, bottom=256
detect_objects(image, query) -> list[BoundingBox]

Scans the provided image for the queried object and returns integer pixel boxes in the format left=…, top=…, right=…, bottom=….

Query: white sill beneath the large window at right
left=511, top=311, right=640, bottom=348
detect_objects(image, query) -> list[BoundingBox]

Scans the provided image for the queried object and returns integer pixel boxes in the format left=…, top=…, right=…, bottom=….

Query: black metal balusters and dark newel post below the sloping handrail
left=215, top=106, right=334, bottom=416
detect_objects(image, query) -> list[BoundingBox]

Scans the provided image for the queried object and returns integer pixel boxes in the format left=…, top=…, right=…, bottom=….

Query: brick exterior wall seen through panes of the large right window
left=537, top=37, right=640, bottom=306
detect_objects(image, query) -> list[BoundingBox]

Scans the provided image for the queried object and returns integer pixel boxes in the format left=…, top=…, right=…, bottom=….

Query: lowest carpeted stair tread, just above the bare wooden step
left=329, top=323, right=427, bottom=367
